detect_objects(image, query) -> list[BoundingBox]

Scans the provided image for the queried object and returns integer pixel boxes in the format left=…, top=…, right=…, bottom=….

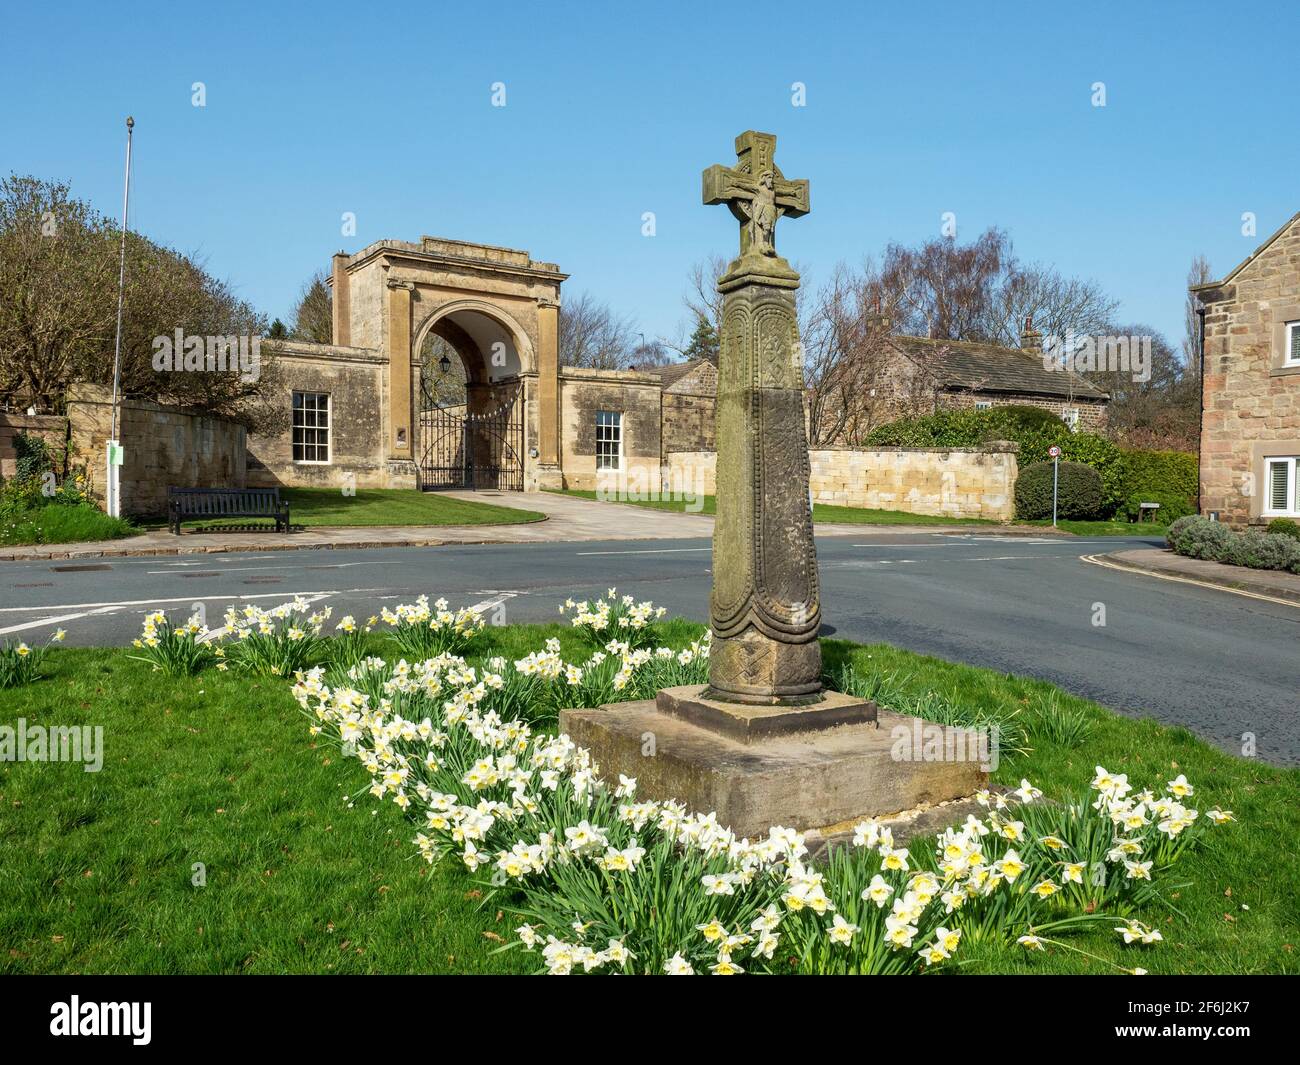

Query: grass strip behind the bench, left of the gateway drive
left=153, top=488, right=546, bottom=529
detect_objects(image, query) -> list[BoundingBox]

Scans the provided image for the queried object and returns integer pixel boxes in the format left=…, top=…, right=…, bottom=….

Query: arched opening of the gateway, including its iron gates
left=416, top=303, right=525, bottom=492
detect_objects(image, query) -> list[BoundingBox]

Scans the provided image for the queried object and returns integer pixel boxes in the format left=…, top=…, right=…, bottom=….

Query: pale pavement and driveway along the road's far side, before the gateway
left=0, top=492, right=1060, bottom=562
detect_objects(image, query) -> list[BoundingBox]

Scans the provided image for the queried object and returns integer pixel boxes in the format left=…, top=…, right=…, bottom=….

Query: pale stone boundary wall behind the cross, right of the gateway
left=666, top=445, right=1018, bottom=521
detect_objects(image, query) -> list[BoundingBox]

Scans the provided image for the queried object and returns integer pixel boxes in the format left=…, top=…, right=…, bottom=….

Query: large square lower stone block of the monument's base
left=560, top=700, right=988, bottom=839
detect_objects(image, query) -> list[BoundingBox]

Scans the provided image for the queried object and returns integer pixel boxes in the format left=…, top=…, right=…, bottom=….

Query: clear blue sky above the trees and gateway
left=0, top=0, right=1300, bottom=343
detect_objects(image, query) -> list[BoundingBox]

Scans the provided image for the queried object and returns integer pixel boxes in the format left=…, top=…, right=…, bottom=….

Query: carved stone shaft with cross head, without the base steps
left=703, top=131, right=822, bottom=705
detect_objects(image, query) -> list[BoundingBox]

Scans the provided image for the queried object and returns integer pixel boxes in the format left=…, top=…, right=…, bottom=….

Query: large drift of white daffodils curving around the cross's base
left=294, top=595, right=1232, bottom=975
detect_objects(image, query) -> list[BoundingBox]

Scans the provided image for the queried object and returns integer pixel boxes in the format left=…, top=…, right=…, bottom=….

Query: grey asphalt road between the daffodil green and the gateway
left=0, top=533, right=1300, bottom=765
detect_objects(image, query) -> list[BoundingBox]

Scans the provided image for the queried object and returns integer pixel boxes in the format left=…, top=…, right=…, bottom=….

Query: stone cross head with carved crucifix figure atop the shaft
left=705, top=130, right=809, bottom=256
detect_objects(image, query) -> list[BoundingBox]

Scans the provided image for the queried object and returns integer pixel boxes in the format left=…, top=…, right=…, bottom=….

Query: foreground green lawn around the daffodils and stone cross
left=0, top=622, right=1300, bottom=973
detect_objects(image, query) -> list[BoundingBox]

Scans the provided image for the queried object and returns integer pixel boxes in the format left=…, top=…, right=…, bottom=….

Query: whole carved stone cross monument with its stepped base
left=560, top=131, right=988, bottom=837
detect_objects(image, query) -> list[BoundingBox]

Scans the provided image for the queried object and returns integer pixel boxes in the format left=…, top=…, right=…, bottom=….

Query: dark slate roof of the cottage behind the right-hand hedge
left=891, top=337, right=1110, bottom=402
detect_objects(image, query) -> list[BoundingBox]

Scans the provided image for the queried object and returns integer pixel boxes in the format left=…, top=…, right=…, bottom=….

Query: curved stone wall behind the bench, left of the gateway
left=68, top=384, right=247, bottom=516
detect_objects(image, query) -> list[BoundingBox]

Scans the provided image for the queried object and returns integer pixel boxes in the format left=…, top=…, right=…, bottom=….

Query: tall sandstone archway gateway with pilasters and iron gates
left=325, top=237, right=567, bottom=490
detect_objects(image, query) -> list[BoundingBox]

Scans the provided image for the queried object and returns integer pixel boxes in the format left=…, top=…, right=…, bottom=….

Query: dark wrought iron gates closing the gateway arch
left=420, top=388, right=524, bottom=492
